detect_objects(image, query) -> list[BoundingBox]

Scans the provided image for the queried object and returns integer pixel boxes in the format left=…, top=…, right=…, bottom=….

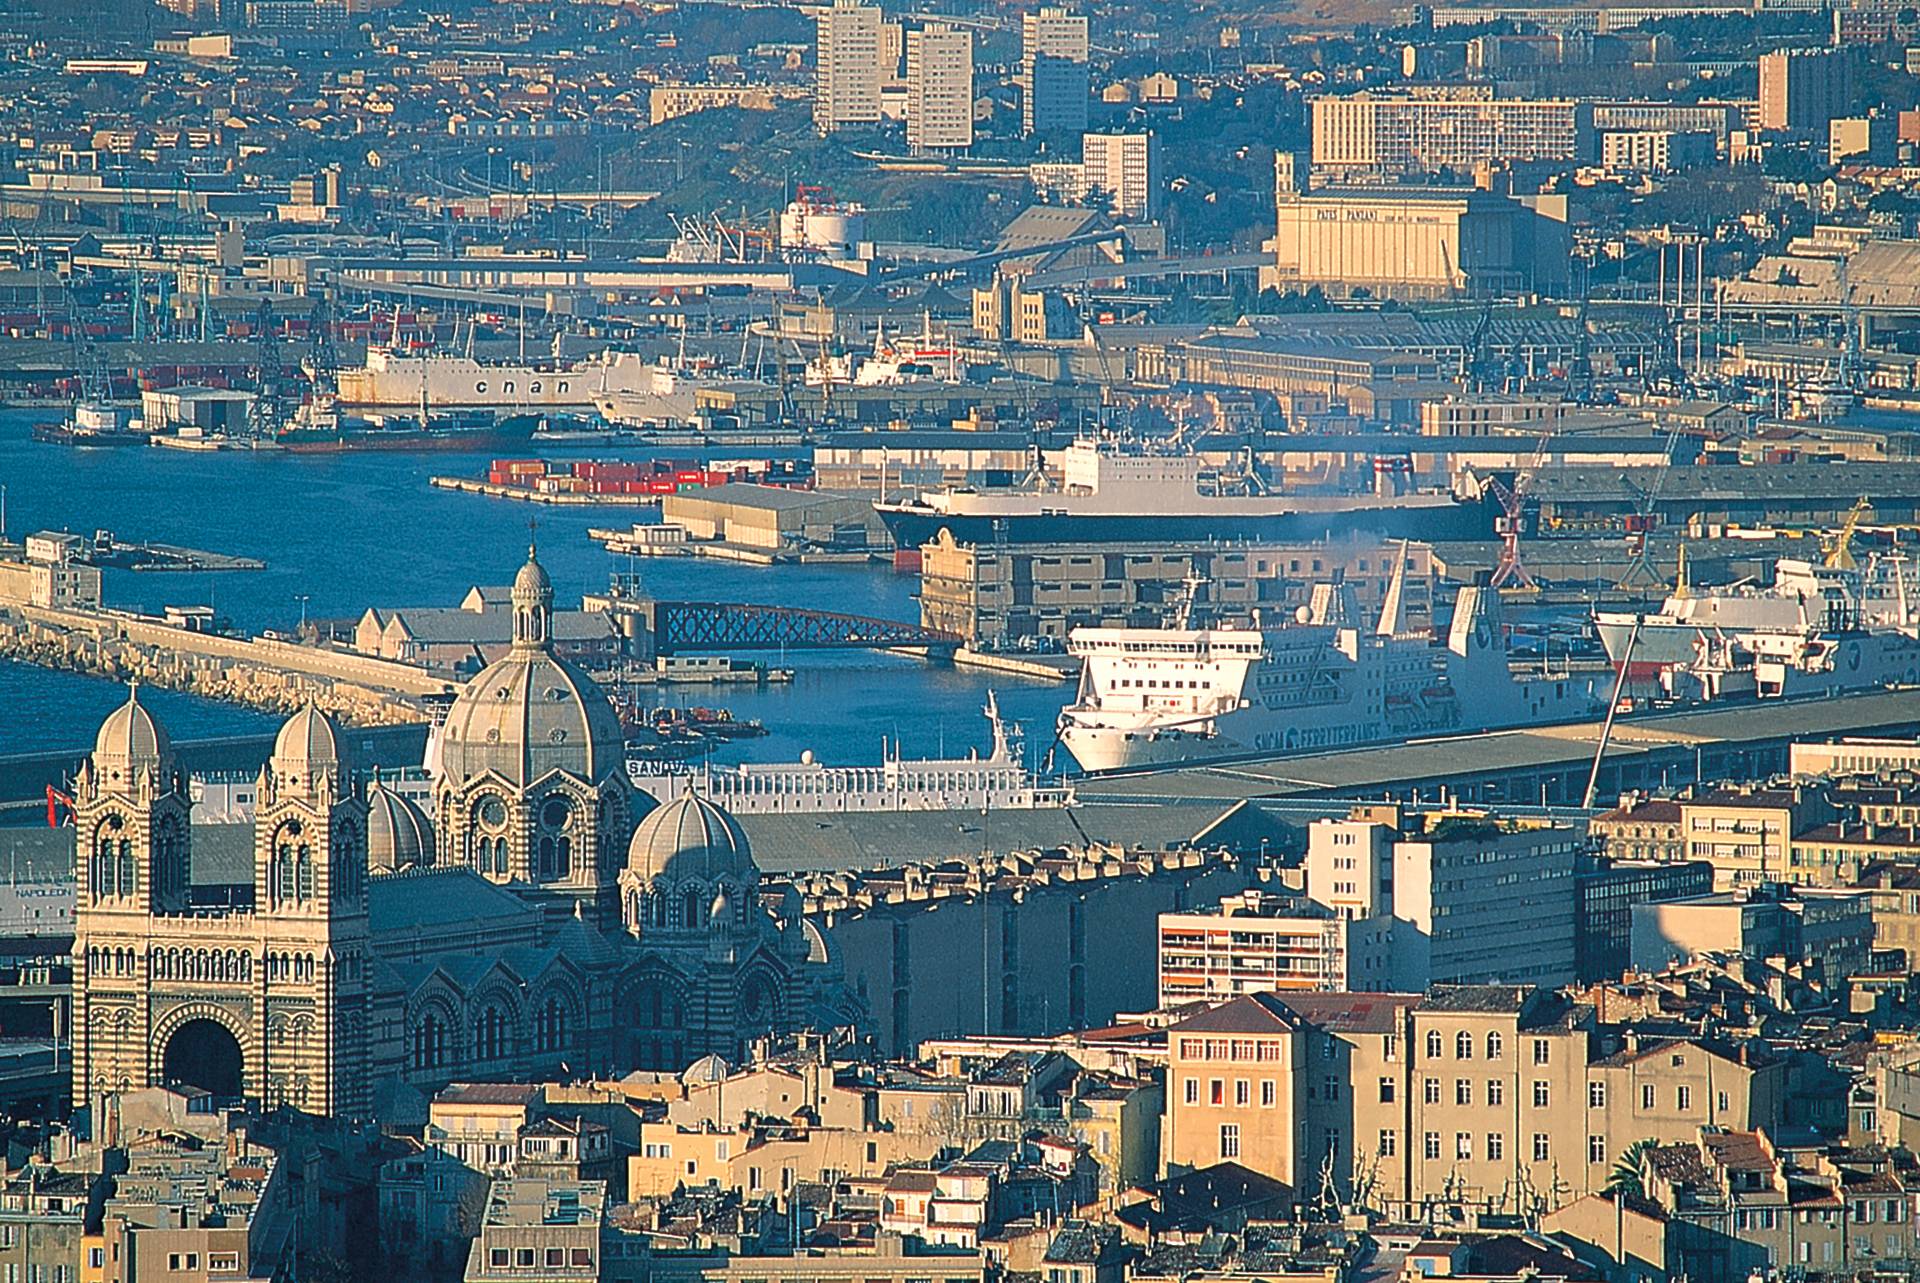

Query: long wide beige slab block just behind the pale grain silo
left=1313, top=90, right=1594, bottom=179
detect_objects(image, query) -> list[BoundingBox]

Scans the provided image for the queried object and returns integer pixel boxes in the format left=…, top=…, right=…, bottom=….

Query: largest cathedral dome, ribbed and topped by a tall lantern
left=440, top=549, right=626, bottom=787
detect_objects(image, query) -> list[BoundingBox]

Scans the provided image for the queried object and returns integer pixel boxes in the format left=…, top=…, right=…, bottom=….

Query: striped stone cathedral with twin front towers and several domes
left=73, top=549, right=860, bottom=1116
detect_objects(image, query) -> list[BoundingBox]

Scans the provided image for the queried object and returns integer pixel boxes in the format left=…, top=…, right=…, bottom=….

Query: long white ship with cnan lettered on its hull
left=336, top=348, right=714, bottom=411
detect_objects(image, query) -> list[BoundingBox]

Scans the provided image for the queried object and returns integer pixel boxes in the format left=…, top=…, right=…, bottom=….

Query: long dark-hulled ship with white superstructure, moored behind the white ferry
left=874, top=440, right=1490, bottom=547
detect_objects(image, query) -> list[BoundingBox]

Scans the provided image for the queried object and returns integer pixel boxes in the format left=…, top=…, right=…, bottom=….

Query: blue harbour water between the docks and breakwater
left=0, top=411, right=1069, bottom=764
